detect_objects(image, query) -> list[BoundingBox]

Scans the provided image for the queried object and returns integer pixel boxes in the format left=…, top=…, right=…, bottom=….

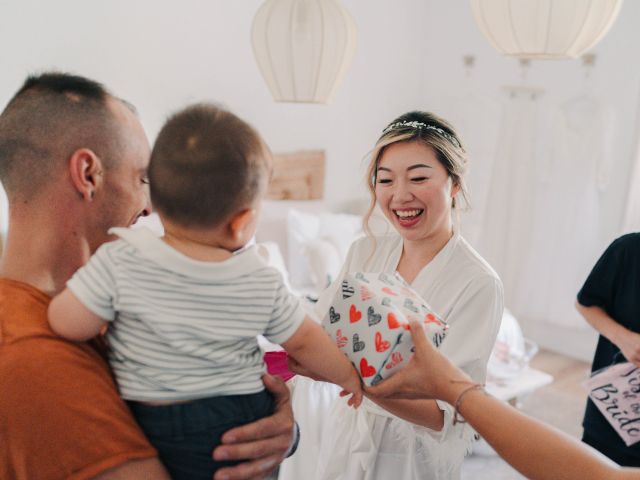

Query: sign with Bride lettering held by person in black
left=583, top=362, right=640, bottom=446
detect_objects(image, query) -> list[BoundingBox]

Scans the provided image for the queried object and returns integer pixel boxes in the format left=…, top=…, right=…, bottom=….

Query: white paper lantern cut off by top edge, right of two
left=471, top=0, right=622, bottom=58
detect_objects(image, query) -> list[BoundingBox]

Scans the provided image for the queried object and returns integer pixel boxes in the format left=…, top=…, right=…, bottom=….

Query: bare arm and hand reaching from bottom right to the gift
left=367, top=323, right=640, bottom=480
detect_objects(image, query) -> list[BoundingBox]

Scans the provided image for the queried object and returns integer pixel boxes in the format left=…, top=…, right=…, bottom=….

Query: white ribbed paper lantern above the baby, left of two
left=251, top=0, right=357, bottom=103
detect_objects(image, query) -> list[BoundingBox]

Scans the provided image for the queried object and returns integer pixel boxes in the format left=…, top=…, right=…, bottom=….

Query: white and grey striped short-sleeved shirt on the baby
left=67, top=228, right=304, bottom=401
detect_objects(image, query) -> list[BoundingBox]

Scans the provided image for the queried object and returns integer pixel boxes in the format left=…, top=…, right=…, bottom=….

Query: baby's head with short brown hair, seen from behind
left=149, top=103, right=271, bottom=250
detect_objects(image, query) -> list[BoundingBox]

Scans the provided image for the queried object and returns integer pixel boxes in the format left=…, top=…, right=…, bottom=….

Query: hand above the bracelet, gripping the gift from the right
left=365, top=322, right=473, bottom=404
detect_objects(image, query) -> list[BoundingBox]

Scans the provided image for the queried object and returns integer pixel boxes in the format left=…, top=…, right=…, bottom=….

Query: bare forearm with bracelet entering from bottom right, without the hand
left=458, top=385, right=640, bottom=480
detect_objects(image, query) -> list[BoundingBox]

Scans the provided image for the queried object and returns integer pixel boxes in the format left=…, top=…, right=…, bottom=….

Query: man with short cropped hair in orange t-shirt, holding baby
left=0, top=73, right=293, bottom=480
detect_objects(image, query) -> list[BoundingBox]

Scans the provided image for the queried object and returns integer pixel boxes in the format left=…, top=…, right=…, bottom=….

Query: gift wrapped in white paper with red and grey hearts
left=322, top=272, right=448, bottom=386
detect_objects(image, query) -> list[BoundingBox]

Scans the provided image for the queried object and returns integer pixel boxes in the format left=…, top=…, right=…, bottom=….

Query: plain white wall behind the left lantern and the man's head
left=0, top=0, right=427, bottom=217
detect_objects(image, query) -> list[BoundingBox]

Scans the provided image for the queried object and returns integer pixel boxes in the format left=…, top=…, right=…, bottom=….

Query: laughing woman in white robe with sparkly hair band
left=284, top=112, right=503, bottom=480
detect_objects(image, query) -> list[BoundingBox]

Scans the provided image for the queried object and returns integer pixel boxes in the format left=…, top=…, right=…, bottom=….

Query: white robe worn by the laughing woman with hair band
left=279, top=234, right=503, bottom=480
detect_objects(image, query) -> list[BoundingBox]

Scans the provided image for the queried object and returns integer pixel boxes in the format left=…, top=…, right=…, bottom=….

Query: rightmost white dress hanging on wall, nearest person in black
left=518, top=95, right=613, bottom=329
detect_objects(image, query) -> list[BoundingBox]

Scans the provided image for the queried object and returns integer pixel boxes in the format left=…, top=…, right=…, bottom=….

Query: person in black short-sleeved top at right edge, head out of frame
left=576, top=233, right=640, bottom=467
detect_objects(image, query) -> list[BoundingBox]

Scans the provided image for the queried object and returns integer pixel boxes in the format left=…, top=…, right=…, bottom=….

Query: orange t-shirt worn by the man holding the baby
left=0, top=279, right=157, bottom=480
